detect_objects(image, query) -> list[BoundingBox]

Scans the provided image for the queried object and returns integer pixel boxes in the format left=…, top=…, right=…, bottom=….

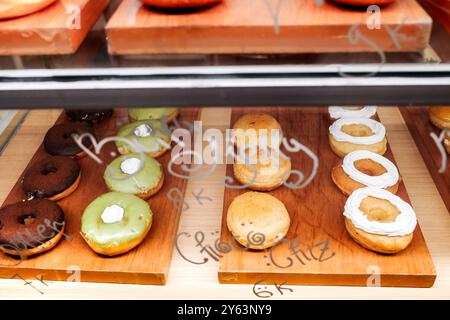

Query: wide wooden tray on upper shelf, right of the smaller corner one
left=106, top=0, right=432, bottom=55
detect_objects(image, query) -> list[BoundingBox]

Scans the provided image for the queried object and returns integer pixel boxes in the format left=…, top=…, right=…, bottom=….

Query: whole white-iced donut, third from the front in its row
left=328, top=118, right=387, bottom=158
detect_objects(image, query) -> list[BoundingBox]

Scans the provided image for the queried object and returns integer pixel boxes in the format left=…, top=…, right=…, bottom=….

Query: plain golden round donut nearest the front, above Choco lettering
left=227, top=191, right=291, bottom=250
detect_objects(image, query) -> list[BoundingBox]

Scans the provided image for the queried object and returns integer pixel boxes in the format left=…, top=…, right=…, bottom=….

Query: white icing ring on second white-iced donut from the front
left=342, top=150, right=400, bottom=189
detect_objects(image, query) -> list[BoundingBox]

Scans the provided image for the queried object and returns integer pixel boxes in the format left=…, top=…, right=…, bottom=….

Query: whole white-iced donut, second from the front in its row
left=331, top=150, right=400, bottom=195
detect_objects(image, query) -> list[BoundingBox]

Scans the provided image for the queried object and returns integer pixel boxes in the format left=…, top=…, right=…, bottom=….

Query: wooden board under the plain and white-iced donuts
left=219, top=107, right=436, bottom=287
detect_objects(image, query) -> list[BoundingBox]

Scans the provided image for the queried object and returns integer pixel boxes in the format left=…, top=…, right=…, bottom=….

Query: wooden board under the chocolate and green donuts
left=0, top=109, right=199, bottom=285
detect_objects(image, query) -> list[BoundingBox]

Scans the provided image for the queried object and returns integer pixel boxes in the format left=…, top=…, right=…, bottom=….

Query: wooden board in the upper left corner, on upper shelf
left=0, top=0, right=110, bottom=55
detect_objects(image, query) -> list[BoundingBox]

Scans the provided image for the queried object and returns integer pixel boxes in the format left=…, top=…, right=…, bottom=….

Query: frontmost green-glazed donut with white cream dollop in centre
left=81, top=192, right=153, bottom=256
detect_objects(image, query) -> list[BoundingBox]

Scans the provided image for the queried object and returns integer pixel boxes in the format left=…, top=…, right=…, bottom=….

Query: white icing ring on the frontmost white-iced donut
left=344, top=187, right=417, bottom=237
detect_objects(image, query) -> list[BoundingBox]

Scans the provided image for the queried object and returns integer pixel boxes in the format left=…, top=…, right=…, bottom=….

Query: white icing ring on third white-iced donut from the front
left=329, top=118, right=386, bottom=145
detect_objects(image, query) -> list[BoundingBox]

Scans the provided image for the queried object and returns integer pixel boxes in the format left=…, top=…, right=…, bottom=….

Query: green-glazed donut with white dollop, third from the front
left=116, top=120, right=171, bottom=158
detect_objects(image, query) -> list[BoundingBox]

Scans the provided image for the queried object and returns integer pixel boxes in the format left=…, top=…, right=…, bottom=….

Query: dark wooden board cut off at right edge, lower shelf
left=400, top=107, right=450, bottom=213
